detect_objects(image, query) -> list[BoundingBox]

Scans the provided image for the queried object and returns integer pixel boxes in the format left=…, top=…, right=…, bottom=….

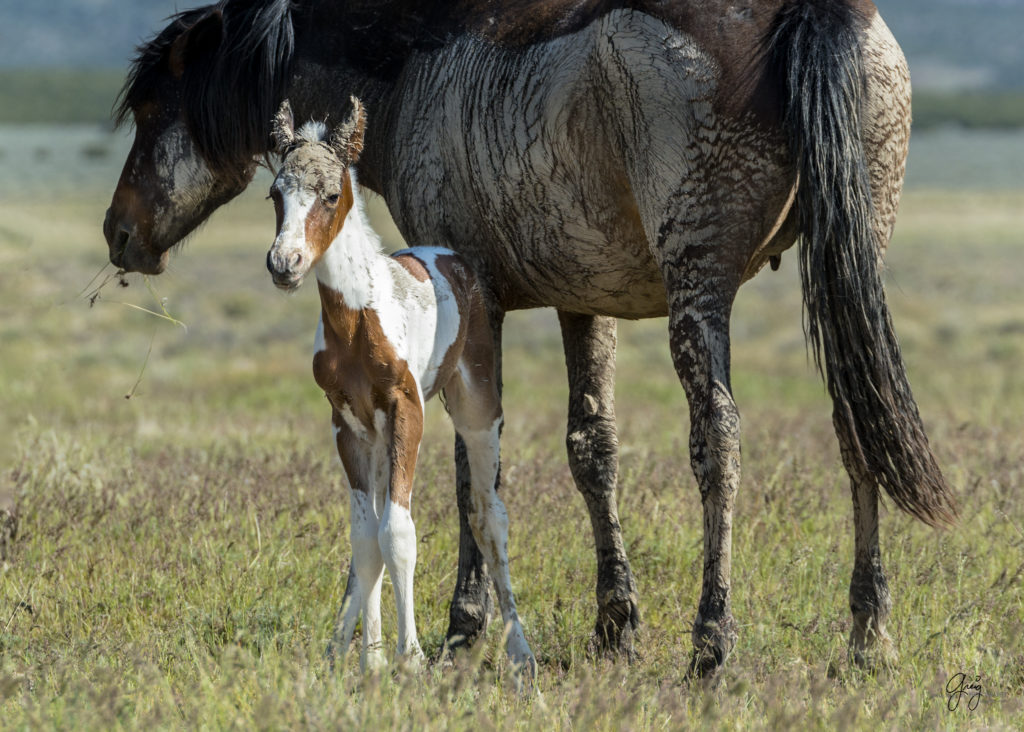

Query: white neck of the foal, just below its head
left=316, top=171, right=389, bottom=310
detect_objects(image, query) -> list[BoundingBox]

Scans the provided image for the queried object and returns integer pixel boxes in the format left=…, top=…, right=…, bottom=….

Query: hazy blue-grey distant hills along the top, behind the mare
left=0, top=0, right=1024, bottom=91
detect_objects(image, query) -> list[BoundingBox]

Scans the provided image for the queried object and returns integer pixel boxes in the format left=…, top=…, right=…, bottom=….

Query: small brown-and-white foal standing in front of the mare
left=267, top=98, right=535, bottom=674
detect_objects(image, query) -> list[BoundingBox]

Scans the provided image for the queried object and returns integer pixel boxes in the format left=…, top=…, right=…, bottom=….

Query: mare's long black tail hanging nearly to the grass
left=767, top=0, right=956, bottom=525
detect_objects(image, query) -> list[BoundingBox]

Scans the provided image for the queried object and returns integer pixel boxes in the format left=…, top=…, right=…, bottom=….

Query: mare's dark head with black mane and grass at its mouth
left=103, top=0, right=294, bottom=274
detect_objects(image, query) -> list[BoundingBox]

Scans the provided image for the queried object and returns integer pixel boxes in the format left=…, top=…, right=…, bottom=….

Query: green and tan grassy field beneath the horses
left=0, top=169, right=1024, bottom=730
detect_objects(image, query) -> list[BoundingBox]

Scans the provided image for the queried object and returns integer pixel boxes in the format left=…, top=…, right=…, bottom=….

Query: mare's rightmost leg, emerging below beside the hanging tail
left=833, top=411, right=895, bottom=669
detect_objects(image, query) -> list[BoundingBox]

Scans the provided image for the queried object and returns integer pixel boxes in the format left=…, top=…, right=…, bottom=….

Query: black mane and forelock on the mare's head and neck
left=115, top=0, right=295, bottom=175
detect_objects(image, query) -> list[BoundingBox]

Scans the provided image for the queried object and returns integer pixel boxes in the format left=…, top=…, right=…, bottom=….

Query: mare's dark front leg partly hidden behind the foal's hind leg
left=444, top=304, right=505, bottom=650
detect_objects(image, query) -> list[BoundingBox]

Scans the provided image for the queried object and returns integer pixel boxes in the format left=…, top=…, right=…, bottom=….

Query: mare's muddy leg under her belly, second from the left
left=558, top=311, right=640, bottom=656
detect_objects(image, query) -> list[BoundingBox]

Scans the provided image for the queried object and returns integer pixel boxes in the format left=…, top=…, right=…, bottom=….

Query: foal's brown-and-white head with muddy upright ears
left=266, top=96, right=367, bottom=290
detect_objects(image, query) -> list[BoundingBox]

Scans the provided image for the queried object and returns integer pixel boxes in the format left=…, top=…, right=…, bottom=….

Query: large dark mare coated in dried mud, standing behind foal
left=103, top=0, right=954, bottom=673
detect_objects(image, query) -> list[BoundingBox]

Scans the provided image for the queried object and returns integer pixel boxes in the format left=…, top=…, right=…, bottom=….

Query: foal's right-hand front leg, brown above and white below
left=378, top=393, right=423, bottom=665
